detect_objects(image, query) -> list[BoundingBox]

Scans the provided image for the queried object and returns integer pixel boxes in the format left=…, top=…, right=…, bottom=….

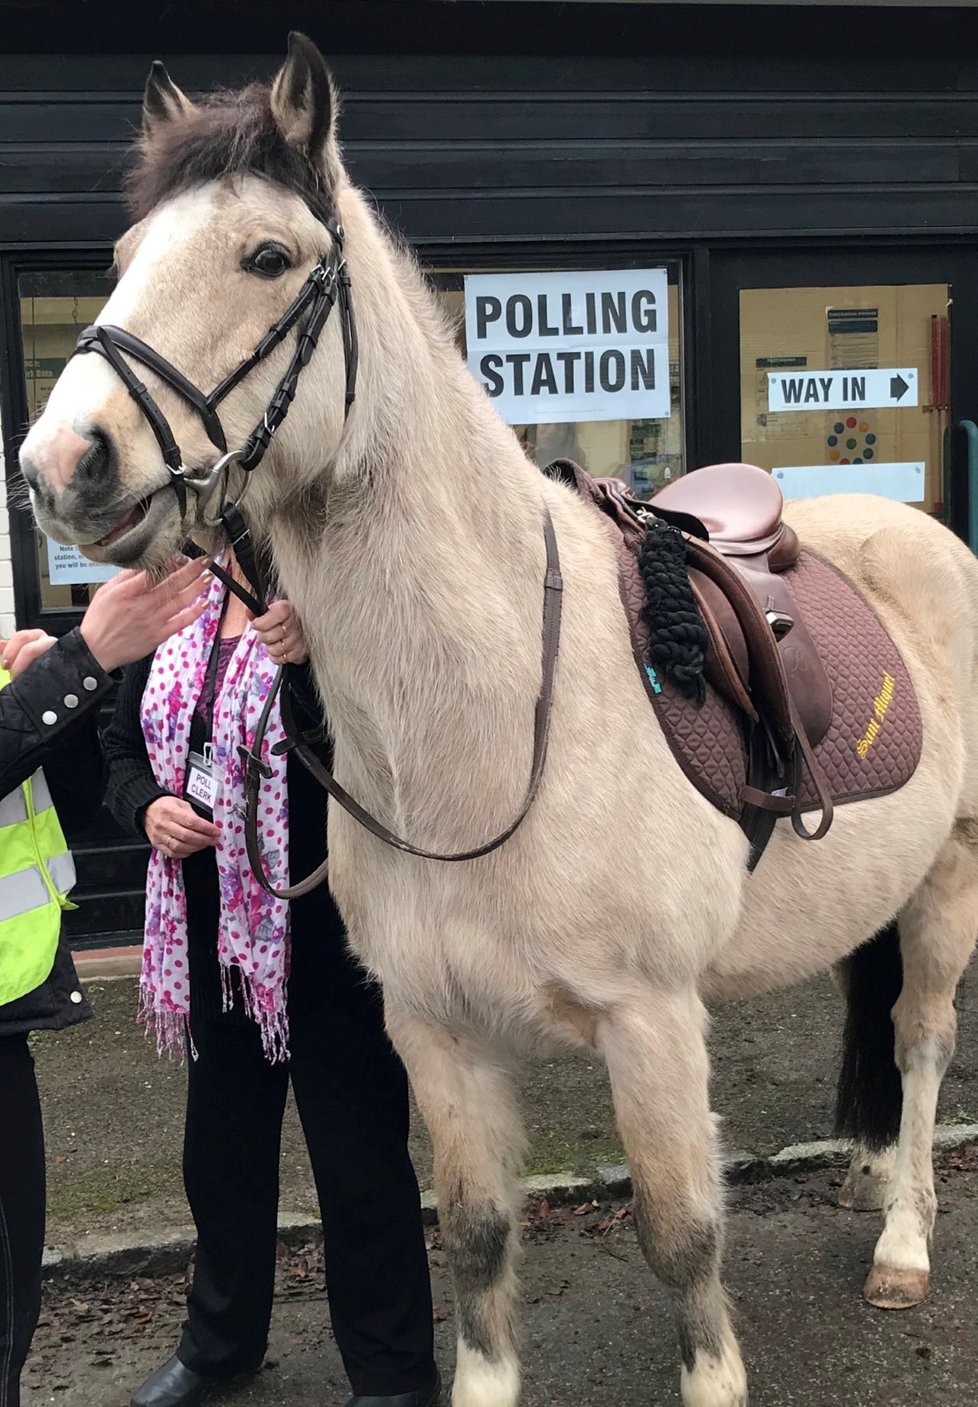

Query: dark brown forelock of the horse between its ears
left=127, top=83, right=332, bottom=219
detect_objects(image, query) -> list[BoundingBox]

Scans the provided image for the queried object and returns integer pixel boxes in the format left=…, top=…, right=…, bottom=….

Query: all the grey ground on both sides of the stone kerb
left=24, top=972, right=978, bottom=1407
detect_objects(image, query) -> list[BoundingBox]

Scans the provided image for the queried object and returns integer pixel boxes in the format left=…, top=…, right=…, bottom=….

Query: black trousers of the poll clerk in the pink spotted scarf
left=177, top=857, right=435, bottom=1396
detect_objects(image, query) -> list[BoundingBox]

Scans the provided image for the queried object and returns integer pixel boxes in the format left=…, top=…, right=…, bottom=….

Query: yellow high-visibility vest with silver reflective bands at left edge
left=0, top=668, right=75, bottom=1006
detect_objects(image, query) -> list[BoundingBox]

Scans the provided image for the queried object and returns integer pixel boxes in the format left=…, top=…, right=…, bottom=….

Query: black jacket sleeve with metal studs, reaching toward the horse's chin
left=0, top=630, right=114, bottom=798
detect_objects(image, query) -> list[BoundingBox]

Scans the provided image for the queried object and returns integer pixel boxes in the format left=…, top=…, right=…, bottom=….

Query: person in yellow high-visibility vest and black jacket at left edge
left=0, top=563, right=213, bottom=1407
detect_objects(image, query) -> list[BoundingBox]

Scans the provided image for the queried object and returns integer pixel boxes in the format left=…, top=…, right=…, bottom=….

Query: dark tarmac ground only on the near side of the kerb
left=24, top=1147, right=978, bottom=1407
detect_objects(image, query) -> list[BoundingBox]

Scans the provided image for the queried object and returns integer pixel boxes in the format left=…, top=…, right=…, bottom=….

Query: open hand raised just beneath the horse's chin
left=80, top=557, right=210, bottom=674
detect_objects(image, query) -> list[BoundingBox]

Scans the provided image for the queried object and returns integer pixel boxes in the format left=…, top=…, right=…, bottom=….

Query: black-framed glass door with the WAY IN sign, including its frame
left=715, top=248, right=978, bottom=546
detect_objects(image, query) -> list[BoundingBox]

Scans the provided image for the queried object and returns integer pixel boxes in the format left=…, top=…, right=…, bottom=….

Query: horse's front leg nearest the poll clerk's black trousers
left=387, top=1000, right=523, bottom=1407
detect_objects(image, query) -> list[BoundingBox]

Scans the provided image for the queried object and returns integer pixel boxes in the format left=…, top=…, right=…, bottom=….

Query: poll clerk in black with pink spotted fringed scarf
left=106, top=559, right=439, bottom=1407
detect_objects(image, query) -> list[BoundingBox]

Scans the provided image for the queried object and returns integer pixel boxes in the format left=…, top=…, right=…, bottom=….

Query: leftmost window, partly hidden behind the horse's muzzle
left=20, top=269, right=114, bottom=611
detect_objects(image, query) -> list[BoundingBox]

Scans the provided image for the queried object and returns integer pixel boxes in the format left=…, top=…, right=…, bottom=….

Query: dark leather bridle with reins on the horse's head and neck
left=75, top=210, right=563, bottom=899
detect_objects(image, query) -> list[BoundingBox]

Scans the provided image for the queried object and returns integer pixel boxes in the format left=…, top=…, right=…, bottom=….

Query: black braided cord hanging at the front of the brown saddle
left=639, top=521, right=708, bottom=705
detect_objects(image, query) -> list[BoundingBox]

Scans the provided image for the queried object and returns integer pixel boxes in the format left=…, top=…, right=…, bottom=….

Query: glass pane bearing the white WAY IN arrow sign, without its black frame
left=740, top=283, right=950, bottom=516
